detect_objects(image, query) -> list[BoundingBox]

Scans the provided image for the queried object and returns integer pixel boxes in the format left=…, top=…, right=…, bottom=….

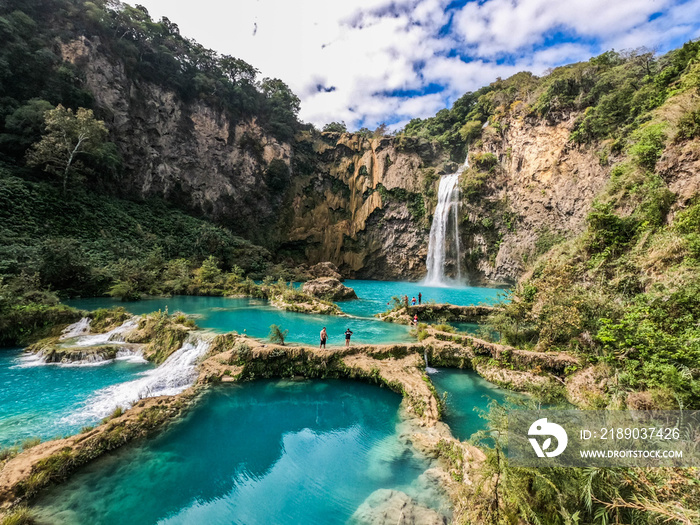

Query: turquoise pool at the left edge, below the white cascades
left=0, top=349, right=153, bottom=446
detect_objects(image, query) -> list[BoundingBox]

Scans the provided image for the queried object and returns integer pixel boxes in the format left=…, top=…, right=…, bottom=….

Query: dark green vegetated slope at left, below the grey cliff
left=0, top=168, right=270, bottom=295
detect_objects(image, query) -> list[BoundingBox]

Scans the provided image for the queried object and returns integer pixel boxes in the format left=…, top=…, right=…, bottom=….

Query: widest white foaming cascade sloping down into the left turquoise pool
left=66, top=336, right=211, bottom=424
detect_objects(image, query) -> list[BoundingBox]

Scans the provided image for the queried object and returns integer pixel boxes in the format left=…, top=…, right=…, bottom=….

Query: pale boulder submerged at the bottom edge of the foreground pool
left=349, top=489, right=447, bottom=525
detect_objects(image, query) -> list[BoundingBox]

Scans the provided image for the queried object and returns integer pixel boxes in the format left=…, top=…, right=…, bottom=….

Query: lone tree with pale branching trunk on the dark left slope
left=27, top=104, right=108, bottom=193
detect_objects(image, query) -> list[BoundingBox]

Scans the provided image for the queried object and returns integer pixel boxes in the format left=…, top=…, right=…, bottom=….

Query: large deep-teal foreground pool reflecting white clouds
left=36, top=381, right=444, bottom=525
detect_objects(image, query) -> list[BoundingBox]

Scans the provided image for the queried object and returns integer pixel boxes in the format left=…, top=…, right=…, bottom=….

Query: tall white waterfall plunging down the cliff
left=424, top=154, right=469, bottom=286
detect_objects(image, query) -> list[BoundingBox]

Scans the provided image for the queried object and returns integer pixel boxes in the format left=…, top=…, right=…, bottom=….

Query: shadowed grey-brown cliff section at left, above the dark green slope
left=61, top=38, right=292, bottom=243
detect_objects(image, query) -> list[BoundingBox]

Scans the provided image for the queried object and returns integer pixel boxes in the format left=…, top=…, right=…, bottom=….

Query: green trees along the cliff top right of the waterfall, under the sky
left=403, top=42, right=700, bottom=155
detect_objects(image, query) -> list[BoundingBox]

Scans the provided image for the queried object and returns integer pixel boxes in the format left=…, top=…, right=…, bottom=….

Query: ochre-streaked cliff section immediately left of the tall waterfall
left=285, top=133, right=444, bottom=279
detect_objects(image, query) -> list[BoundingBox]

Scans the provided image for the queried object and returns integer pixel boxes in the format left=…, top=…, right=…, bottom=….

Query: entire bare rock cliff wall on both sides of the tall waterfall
left=62, top=38, right=616, bottom=283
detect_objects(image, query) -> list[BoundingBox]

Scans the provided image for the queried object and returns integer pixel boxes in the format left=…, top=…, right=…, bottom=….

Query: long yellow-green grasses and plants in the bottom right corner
left=460, top=402, right=700, bottom=525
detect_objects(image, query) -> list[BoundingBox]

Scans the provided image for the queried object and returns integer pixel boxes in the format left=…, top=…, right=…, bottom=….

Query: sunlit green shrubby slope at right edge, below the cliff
left=482, top=120, right=700, bottom=408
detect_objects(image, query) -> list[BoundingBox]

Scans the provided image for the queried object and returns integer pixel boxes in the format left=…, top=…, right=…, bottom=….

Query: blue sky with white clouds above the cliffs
left=131, top=0, right=700, bottom=129
